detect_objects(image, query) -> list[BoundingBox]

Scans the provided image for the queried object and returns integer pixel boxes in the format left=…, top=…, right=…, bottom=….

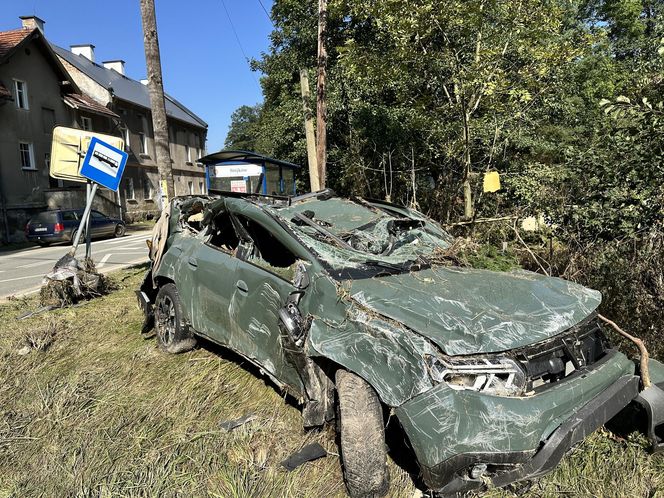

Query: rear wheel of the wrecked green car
left=154, top=284, right=196, bottom=354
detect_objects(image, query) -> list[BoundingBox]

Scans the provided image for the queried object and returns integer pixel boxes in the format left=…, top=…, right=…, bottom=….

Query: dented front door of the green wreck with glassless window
left=224, top=215, right=303, bottom=392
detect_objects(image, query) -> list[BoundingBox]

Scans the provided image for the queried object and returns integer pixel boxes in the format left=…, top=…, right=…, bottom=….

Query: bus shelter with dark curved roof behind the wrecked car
left=199, top=150, right=299, bottom=195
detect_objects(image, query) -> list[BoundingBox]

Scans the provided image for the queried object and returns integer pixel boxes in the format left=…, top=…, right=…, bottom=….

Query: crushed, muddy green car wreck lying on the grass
left=137, top=191, right=664, bottom=496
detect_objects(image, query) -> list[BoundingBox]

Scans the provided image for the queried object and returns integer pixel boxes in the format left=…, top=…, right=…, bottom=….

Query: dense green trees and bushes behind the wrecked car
left=222, top=0, right=664, bottom=340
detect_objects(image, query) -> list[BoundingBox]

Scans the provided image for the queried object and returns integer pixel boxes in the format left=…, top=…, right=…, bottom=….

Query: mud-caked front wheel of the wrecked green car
left=336, top=369, right=390, bottom=498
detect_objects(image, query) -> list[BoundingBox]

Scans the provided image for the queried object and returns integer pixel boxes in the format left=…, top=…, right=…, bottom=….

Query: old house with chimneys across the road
left=0, top=16, right=207, bottom=243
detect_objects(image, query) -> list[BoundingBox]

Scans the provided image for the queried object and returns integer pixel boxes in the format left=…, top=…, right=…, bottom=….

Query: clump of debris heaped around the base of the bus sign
left=39, top=255, right=113, bottom=308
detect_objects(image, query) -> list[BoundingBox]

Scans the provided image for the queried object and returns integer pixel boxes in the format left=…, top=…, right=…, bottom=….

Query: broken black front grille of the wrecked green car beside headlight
left=514, top=317, right=610, bottom=392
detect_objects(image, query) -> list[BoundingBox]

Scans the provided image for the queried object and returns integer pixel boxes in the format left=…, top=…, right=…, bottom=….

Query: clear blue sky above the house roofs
left=0, top=0, right=272, bottom=152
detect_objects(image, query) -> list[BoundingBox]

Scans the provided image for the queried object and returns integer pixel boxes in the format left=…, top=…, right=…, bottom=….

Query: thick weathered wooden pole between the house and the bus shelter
left=140, top=0, right=175, bottom=210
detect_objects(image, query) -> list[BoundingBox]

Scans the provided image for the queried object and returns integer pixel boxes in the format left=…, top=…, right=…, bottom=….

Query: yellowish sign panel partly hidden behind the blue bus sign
left=49, top=126, right=124, bottom=183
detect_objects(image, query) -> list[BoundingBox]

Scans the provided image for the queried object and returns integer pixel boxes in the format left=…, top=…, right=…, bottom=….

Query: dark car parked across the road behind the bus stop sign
left=25, top=209, right=126, bottom=246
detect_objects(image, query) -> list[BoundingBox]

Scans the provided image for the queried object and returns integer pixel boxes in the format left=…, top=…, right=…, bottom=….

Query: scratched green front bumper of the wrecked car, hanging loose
left=396, top=351, right=664, bottom=494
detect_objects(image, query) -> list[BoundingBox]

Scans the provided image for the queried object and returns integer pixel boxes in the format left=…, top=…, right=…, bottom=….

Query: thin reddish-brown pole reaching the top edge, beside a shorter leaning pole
left=316, top=0, right=327, bottom=189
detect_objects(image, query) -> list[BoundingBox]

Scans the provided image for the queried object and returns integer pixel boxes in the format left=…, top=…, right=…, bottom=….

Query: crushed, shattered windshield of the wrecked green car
left=278, top=198, right=452, bottom=272
